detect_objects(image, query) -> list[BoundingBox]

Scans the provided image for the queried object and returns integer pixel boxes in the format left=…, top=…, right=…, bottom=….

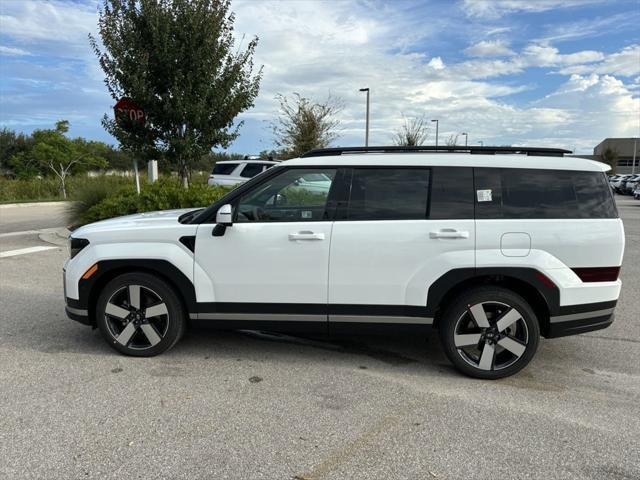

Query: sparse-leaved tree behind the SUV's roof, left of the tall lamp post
left=271, top=93, right=343, bottom=158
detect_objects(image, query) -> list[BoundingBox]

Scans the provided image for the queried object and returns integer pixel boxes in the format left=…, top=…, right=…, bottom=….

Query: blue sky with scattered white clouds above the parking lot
left=0, top=0, right=640, bottom=154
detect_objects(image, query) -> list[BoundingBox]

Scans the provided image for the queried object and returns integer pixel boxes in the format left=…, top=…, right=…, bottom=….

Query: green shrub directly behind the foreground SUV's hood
left=79, top=178, right=229, bottom=223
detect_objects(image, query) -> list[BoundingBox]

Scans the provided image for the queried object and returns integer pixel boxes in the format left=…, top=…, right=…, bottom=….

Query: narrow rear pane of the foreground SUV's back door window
left=429, top=167, right=473, bottom=220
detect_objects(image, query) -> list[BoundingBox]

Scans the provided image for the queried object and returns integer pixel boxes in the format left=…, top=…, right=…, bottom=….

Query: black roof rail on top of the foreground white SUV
left=302, top=145, right=572, bottom=158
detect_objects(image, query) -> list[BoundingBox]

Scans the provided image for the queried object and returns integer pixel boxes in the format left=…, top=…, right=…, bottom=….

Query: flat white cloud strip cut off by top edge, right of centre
left=463, top=0, right=605, bottom=18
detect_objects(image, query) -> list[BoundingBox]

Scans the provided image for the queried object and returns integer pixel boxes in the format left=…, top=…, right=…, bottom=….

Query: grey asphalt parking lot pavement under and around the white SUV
left=0, top=197, right=640, bottom=479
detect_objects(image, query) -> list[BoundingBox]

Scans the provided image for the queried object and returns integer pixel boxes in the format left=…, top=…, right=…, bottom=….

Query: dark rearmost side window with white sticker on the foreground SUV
left=475, top=168, right=617, bottom=218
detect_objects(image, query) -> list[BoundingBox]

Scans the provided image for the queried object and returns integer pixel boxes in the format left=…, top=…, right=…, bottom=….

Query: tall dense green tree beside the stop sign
left=89, top=0, right=262, bottom=186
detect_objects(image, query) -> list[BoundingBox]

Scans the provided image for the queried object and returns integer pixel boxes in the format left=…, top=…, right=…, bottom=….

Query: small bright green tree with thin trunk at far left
left=31, top=120, right=107, bottom=199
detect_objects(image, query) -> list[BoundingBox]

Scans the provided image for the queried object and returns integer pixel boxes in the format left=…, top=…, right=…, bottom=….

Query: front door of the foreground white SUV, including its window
left=194, top=168, right=337, bottom=323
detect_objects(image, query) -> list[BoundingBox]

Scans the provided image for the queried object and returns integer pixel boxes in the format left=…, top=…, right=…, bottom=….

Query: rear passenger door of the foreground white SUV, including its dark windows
left=329, top=167, right=475, bottom=329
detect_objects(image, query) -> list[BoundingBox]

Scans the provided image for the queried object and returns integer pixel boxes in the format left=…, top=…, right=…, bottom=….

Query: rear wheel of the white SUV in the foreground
left=439, top=286, right=540, bottom=379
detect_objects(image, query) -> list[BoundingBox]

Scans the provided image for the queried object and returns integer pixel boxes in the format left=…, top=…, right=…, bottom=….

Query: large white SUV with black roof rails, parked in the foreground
left=64, top=147, right=624, bottom=378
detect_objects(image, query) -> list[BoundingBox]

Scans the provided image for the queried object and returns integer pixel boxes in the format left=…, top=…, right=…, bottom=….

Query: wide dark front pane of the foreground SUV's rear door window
left=348, top=168, right=429, bottom=220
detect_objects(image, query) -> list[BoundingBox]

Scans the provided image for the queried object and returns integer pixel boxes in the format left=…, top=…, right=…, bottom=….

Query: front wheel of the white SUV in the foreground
left=96, top=272, right=186, bottom=357
